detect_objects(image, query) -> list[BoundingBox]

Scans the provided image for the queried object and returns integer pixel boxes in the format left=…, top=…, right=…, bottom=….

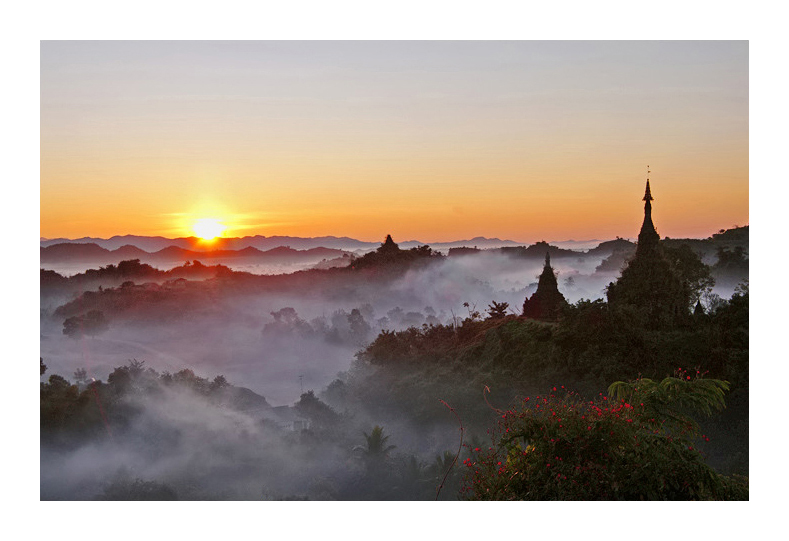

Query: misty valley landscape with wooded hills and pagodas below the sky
left=40, top=226, right=749, bottom=500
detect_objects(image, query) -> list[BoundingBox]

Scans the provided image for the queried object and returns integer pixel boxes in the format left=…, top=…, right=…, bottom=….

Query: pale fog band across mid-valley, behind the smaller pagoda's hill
left=41, top=250, right=615, bottom=404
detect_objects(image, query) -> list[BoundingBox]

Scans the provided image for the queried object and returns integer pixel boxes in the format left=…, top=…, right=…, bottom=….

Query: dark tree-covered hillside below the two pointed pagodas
left=358, top=282, right=748, bottom=438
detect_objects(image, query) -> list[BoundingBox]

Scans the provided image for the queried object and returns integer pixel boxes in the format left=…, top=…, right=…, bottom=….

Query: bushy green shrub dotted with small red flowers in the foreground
left=461, top=378, right=748, bottom=500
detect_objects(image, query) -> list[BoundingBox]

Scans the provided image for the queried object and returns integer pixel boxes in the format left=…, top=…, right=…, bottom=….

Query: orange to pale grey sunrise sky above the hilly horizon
left=40, top=41, right=749, bottom=243
